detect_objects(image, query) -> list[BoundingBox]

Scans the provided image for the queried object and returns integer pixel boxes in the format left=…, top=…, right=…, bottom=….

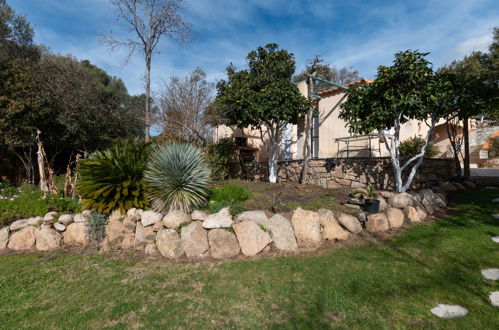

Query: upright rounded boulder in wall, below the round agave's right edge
left=180, top=221, right=210, bottom=258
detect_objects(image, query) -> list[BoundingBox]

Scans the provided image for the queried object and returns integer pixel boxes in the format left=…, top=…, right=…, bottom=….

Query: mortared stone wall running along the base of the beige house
left=230, top=157, right=456, bottom=190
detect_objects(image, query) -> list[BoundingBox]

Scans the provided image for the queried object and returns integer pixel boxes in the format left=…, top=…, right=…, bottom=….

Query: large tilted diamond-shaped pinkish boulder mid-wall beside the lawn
left=232, top=220, right=272, bottom=256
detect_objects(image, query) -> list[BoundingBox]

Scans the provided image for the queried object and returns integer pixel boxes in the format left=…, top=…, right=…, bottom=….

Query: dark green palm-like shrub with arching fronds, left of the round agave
left=77, top=140, right=149, bottom=214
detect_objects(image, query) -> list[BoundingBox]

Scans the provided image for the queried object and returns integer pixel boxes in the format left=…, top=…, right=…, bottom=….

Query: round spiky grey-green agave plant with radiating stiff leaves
left=144, top=142, right=210, bottom=212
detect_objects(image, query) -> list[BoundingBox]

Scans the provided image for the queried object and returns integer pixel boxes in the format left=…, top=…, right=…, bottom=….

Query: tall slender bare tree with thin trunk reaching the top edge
left=104, top=0, right=189, bottom=142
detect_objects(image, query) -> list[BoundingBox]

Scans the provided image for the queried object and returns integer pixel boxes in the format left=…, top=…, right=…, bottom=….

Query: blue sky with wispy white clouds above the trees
left=7, top=0, right=499, bottom=94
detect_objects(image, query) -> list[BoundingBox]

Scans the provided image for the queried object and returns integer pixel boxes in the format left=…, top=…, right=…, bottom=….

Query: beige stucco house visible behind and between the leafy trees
left=214, top=79, right=498, bottom=166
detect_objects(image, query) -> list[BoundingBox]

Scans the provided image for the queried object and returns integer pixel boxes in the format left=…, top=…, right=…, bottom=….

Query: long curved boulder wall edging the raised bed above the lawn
left=0, top=189, right=452, bottom=260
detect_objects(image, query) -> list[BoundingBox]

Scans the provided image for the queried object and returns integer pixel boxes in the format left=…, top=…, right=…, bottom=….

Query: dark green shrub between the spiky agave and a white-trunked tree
left=208, top=138, right=236, bottom=180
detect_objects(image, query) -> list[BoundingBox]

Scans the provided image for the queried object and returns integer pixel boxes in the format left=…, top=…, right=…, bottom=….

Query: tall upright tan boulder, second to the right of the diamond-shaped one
left=291, top=207, right=322, bottom=247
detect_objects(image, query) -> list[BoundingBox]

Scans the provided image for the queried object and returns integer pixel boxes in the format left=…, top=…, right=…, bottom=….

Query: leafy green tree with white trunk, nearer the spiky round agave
left=215, top=44, right=310, bottom=183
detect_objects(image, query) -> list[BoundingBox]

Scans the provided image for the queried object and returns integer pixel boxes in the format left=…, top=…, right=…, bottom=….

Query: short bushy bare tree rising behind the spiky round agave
left=155, top=68, right=214, bottom=146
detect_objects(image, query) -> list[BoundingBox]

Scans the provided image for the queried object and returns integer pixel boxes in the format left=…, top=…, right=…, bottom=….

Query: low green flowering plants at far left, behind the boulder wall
left=0, top=182, right=81, bottom=227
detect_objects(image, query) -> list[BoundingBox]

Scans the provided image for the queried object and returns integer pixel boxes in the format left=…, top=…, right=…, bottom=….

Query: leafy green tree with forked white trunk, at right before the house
left=340, top=50, right=451, bottom=192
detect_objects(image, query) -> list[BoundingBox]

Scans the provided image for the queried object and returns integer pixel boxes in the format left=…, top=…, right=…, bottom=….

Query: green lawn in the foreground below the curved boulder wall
left=0, top=191, right=499, bottom=329
